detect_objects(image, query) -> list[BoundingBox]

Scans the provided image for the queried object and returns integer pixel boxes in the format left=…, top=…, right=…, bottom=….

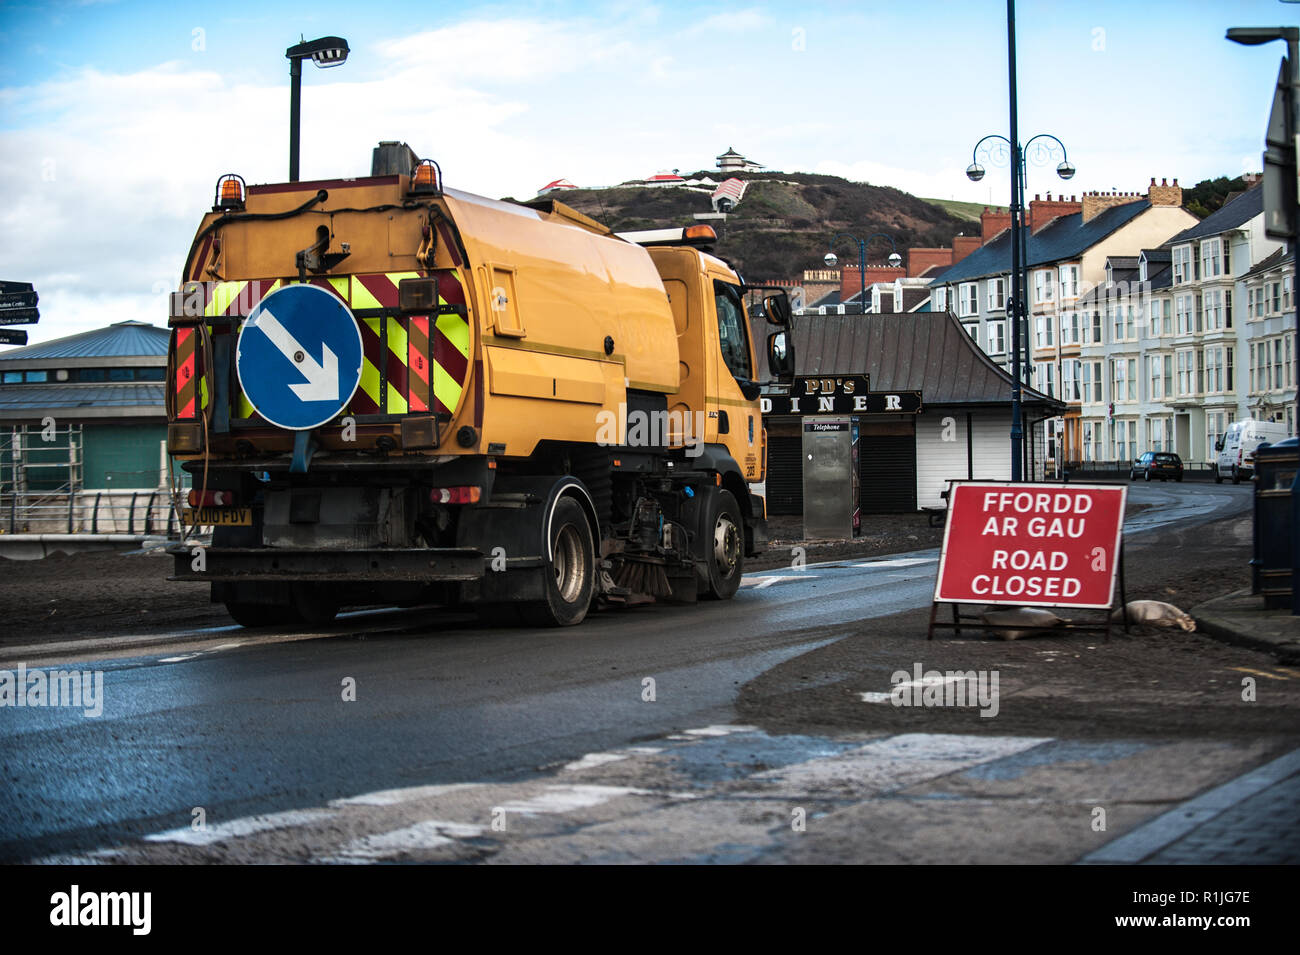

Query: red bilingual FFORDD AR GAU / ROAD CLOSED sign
left=935, top=481, right=1128, bottom=607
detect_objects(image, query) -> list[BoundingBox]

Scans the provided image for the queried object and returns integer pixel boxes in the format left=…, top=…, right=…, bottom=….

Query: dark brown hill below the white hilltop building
left=506, top=170, right=972, bottom=281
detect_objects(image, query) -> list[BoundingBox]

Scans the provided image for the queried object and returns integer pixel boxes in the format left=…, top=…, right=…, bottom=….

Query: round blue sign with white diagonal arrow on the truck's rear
left=235, top=285, right=361, bottom=431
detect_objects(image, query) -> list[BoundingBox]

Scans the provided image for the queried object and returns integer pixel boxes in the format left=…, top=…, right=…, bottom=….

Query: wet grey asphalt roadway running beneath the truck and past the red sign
left=0, top=482, right=1251, bottom=860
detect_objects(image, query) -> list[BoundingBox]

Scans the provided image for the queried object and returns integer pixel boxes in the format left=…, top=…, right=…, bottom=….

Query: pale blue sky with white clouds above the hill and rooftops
left=0, top=0, right=1300, bottom=340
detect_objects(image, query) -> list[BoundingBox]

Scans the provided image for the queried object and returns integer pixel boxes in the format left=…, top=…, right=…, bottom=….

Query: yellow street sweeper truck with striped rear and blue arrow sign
left=168, top=143, right=793, bottom=626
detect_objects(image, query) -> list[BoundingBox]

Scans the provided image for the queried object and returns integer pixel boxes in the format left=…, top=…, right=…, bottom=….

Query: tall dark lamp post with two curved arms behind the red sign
left=966, top=0, right=1075, bottom=481
